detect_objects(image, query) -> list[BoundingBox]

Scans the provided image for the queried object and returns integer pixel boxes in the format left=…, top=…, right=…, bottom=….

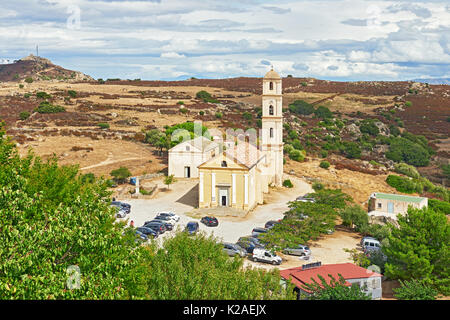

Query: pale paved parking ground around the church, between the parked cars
left=118, top=177, right=359, bottom=269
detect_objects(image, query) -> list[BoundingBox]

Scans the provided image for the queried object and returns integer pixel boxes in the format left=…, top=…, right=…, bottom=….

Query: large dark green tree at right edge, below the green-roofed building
left=382, top=207, right=450, bottom=295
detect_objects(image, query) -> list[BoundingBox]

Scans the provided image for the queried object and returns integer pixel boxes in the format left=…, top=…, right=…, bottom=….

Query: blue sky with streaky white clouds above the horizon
left=0, top=0, right=450, bottom=81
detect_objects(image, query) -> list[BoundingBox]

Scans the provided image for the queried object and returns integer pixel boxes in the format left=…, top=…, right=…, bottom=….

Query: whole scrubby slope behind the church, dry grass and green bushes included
left=0, top=64, right=450, bottom=203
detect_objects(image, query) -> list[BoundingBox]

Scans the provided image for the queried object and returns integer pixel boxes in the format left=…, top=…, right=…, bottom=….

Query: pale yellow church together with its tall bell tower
left=169, top=69, right=283, bottom=211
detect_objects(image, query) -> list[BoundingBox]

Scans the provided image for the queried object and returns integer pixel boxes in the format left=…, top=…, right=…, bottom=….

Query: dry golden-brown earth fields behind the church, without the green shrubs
left=0, top=78, right=450, bottom=189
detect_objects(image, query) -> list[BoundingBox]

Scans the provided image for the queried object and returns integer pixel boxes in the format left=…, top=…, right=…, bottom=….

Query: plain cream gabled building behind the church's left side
left=168, top=137, right=220, bottom=178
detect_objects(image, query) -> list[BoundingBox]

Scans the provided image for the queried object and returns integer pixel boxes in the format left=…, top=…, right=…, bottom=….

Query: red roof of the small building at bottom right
left=280, top=263, right=382, bottom=291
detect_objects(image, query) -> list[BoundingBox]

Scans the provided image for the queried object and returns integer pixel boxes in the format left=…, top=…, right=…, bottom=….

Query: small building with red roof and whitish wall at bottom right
left=280, top=263, right=383, bottom=300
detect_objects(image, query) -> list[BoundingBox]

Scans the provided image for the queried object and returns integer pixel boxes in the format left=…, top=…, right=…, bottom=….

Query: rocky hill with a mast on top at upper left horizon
left=0, top=54, right=93, bottom=82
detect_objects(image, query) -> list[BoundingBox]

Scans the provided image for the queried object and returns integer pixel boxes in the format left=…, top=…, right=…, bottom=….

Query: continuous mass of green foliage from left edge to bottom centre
left=0, top=125, right=294, bottom=300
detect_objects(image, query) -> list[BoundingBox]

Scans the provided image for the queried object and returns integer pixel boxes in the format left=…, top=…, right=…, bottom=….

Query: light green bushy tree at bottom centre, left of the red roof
left=145, top=232, right=294, bottom=300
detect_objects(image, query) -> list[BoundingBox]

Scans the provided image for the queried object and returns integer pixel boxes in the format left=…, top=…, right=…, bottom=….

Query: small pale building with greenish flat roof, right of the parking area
left=368, top=192, right=428, bottom=220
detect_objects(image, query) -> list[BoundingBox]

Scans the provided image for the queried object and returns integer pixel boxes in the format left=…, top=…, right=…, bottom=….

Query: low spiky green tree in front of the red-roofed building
left=303, top=274, right=371, bottom=300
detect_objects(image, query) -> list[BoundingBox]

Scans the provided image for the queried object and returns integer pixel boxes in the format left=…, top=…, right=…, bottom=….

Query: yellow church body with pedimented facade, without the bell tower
left=198, top=142, right=268, bottom=211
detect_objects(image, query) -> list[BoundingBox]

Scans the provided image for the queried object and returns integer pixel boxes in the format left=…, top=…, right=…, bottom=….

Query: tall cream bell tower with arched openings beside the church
left=262, top=68, right=283, bottom=186
